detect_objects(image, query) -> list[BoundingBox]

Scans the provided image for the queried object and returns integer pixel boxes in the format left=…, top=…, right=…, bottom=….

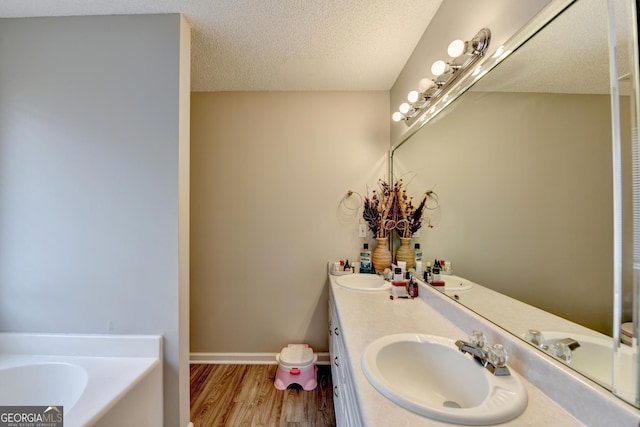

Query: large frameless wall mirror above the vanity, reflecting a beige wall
left=392, top=0, right=640, bottom=406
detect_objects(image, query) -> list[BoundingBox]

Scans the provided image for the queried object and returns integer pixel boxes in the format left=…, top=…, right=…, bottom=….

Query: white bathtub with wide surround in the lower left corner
left=0, top=333, right=163, bottom=427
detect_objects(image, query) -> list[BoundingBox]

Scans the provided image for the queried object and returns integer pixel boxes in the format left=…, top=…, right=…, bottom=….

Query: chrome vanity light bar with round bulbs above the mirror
left=391, top=28, right=491, bottom=126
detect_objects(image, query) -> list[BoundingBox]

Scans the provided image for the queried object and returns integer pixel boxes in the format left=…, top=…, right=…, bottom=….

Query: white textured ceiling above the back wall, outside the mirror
left=0, top=0, right=442, bottom=91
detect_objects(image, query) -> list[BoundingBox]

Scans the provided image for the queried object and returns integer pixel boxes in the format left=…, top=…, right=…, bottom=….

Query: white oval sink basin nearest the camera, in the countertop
left=362, top=334, right=527, bottom=425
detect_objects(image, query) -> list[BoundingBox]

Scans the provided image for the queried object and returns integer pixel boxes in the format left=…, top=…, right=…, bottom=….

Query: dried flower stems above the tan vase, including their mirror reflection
left=362, top=179, right=438, bottom=238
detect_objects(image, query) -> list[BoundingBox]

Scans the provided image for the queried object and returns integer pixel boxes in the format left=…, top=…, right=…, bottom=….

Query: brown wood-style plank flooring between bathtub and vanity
left=191, top=364, right=336, bottom=427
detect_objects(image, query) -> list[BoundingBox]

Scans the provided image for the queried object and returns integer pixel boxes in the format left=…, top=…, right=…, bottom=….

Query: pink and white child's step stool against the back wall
left=273, top=344, right=318, bottom=391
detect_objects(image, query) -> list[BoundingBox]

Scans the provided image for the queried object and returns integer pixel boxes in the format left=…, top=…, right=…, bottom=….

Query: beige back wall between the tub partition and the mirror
left=191, top=92, right=389, bottom=353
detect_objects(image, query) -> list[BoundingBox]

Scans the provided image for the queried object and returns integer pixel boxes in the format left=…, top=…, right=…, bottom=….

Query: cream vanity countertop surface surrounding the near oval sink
left=330, top=276, right=583, bottom=427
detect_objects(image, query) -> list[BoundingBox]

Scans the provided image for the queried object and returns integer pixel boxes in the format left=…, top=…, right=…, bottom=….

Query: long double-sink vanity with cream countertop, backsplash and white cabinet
left=329, top=274, right=640, bottom=427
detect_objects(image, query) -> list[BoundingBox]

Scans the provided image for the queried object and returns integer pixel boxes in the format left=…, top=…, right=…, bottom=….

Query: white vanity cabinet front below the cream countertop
left=329, top=298, right=364, bottom=427
